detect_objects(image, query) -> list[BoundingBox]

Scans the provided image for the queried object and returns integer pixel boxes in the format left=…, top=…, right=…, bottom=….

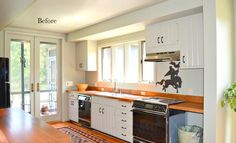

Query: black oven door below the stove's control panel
left=133, top=108, right=168, bottom=143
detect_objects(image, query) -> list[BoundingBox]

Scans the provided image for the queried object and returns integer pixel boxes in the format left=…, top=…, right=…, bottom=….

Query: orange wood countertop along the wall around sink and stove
left=68, top=91, right=204, bottom=113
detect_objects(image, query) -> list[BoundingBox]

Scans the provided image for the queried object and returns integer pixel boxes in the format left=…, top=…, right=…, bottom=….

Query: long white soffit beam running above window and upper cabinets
left=67, top=0, right=202, bottom=41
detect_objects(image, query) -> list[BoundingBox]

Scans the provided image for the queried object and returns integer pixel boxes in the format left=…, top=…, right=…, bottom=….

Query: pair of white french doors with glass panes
left=6, top=34, right=61, bottom=121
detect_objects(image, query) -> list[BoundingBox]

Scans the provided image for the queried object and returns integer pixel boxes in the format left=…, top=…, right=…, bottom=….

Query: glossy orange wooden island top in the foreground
left=0, top=108, right=70, bottom=143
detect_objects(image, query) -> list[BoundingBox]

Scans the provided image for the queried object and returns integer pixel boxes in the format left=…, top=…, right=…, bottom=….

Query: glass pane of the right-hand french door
left=39, top=42, right=57, bottom=116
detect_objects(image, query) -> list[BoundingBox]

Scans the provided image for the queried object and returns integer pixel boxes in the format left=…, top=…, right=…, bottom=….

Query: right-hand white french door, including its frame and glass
left=34, top=38, right=61, bottom=121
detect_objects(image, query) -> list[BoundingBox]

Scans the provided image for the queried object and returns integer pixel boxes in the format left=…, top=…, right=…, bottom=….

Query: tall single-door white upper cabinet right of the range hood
left=179, top=14, right=204, bottom=69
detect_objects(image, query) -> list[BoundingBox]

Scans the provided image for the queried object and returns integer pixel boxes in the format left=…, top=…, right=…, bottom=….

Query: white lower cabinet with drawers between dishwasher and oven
left=91, top=96, right=133, bottom=142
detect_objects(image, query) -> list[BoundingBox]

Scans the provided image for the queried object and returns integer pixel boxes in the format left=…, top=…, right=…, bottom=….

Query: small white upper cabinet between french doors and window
left=76, top=41, right=97, bottom=71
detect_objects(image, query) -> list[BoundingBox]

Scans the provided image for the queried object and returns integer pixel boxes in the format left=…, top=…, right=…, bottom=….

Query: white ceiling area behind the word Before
left=9, top=0, right=162, bottom=33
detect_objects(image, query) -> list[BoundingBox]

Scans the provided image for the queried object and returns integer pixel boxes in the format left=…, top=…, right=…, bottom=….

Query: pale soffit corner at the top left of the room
left=0, top=0, right=35, bottom=30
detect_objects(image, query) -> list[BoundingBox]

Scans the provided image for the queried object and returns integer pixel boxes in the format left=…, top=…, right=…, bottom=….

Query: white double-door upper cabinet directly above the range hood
left=145, top=20, right=179, bottom=53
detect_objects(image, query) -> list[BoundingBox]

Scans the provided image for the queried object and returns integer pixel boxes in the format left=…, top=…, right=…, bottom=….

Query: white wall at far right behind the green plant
left=203, top=0, right=236, bottom=143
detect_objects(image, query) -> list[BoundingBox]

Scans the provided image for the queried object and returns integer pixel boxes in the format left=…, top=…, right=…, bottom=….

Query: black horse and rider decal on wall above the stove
left=156, top=62, right=182, bottom=93
